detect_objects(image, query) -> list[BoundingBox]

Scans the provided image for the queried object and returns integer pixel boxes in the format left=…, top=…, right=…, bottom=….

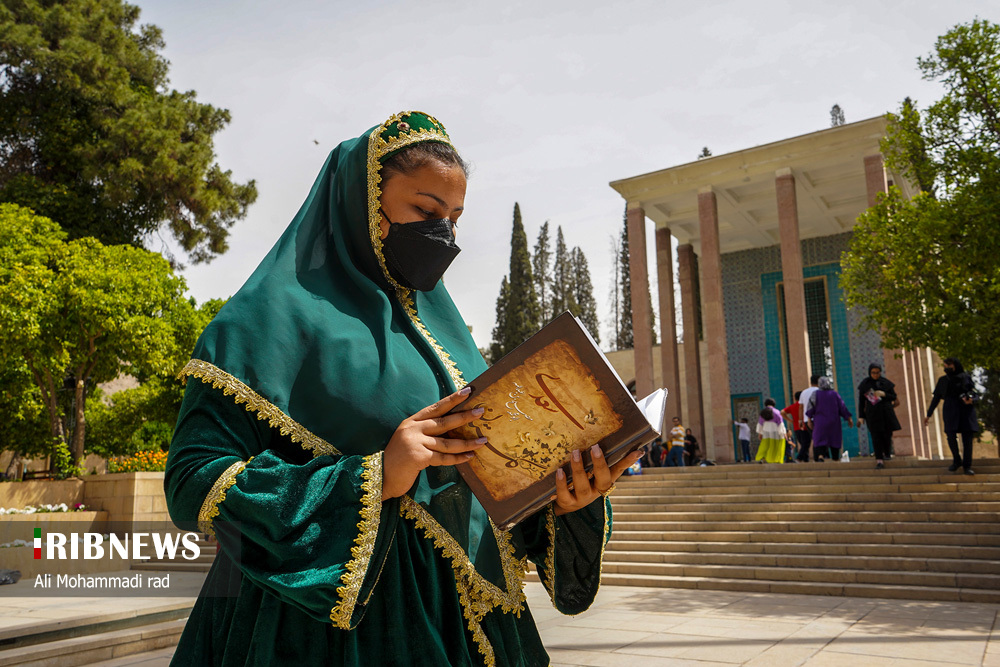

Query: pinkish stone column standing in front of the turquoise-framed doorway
left=774, top=169, right=812, bottom=402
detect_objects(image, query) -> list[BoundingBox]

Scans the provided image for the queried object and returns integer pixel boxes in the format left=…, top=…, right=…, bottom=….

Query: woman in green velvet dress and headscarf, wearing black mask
left=164, top=112, right=638, bottom=667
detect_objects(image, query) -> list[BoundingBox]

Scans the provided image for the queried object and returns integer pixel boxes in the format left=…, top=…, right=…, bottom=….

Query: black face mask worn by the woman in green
left=379, top=209, right=462, bottom=292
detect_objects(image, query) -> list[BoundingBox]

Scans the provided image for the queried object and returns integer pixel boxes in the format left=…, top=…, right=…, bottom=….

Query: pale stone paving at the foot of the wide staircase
left=62, top=583, right=1000, bottom=667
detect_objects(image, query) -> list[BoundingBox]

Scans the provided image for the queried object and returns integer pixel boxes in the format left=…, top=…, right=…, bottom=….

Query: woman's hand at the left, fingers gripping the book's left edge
left=382, top=387, right=486, bottom=500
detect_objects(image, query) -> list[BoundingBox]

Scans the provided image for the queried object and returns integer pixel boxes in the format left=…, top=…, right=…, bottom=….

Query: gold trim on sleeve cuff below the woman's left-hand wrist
left=330, top=452, right=384, bottom=630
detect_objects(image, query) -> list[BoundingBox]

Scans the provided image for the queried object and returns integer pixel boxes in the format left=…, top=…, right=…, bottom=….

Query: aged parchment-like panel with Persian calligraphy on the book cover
left=454, top=339, right=622, bottom=500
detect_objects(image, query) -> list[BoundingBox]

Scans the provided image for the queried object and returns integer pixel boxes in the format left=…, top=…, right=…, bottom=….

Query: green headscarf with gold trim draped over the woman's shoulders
left=184, top=112, right=523, bottom=611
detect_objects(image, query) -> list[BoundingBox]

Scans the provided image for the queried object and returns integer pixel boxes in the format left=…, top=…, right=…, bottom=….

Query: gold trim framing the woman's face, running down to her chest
left=367, top=111, right=465, bottom=389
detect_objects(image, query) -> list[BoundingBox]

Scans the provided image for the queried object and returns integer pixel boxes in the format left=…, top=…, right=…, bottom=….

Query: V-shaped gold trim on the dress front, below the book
left=399, top=496, right=527, bottom=665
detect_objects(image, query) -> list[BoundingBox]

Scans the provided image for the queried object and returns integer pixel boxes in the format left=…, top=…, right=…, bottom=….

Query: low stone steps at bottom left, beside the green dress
left=0, top=600, right=194, bottom=667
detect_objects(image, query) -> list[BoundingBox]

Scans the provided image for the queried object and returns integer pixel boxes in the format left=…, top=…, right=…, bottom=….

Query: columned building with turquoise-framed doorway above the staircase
left=611, top=117, right=947, bottom=461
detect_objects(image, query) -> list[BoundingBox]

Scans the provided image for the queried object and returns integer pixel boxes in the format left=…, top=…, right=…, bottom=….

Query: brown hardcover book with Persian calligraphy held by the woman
left=452, top=312, right=667, bottom=530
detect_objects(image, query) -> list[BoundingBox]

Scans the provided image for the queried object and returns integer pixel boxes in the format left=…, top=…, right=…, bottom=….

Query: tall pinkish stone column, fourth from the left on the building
left=698, top=187, right=733, bottom=461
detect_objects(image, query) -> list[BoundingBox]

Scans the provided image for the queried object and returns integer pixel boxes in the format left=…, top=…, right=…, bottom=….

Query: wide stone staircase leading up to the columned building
left=602, top=459, right=1000, bottom=603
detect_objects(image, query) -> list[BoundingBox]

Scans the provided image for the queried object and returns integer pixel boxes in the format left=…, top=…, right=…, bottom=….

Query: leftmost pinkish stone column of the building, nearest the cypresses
left=627, top=204, right=653, bottom=398
